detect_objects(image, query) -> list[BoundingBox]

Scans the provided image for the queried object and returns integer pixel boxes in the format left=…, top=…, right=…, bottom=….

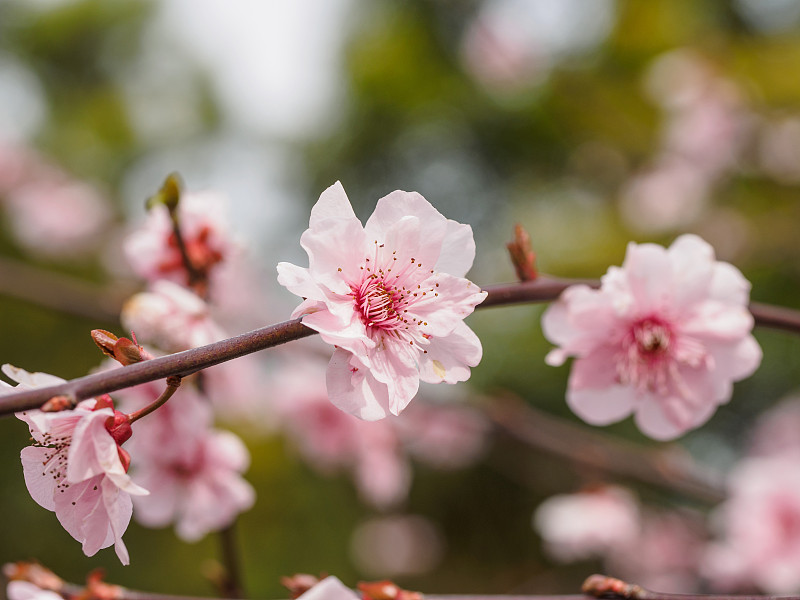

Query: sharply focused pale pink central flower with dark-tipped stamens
left=278, top=182, right=486, bottom=421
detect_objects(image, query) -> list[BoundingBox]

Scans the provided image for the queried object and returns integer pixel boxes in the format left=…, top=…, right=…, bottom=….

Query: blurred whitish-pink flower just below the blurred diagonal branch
left=533, top=486, right=640, bottom=562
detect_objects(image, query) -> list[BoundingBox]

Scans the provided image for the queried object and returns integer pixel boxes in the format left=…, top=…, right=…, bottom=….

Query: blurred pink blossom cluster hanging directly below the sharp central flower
left=271, top=356, right=489, bottom=510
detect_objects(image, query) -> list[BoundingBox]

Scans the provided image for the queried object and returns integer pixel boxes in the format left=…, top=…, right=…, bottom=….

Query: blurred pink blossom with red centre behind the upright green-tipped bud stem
left=124, top=192, right=236, bottom=294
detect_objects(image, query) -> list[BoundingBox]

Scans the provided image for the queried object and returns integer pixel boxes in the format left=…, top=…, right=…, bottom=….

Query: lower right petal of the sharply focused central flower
left=419, top=322, right=483, bottom=383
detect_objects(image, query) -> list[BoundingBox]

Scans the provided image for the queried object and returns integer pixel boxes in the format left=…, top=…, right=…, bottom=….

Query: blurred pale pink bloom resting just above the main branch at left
left=120, top=280, right=226, bottom=352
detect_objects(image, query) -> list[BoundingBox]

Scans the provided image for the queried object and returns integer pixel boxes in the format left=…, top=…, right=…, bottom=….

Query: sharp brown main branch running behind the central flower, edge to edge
left=0, top=276, right=800, bottom=415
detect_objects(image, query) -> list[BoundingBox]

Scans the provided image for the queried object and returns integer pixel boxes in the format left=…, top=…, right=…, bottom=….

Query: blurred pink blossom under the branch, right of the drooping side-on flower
left=114, top=384, right=255, bottom=542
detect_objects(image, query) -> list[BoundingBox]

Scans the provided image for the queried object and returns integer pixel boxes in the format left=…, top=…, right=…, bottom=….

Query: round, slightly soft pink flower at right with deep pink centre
left=542, top=235, right=761, bottom=439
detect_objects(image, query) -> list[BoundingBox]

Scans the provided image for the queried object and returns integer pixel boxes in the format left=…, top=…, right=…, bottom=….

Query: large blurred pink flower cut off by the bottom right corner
left=703, top=452, right=800, bottom=594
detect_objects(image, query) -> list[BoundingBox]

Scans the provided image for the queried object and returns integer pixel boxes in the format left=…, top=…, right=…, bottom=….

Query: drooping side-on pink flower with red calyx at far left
left=3, top=365, right=148, bottom=564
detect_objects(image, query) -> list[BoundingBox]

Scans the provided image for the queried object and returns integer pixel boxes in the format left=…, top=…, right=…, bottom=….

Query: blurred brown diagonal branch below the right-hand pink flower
left=487, top=398, right=725, bottom=504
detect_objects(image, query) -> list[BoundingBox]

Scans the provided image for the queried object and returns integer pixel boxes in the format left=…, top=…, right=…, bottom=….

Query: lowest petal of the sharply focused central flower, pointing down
left=326, top=348, right=389, bottom=421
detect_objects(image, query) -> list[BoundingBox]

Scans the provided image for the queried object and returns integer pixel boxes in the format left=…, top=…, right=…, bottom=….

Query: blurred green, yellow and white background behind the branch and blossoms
left=0, top=0, right=800, bottom=598
